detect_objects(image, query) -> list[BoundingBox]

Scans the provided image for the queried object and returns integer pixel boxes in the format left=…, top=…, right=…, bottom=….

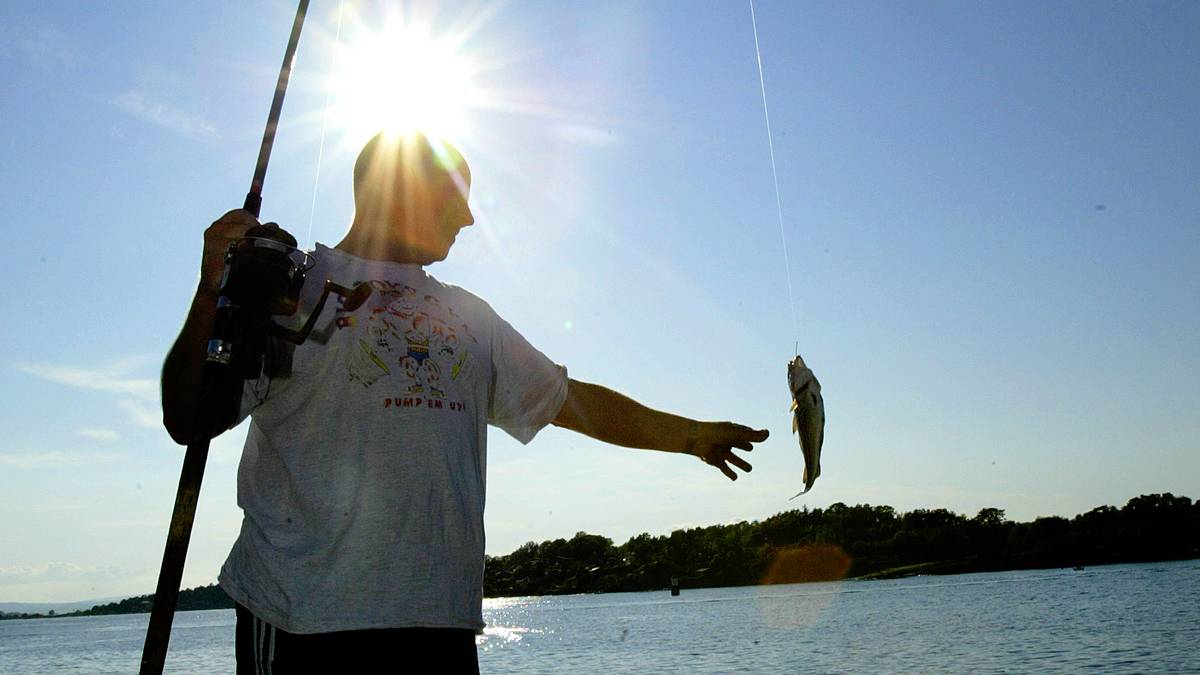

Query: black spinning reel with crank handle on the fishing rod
left=205, top=223, right=371, bottom=429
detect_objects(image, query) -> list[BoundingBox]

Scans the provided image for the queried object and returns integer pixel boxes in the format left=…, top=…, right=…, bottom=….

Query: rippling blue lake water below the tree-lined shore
left=0, top=561, right=1200, bottom=674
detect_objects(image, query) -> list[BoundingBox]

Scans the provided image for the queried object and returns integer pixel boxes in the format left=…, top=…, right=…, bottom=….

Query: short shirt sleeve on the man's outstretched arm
left=487, top=316, right=566, bottom=443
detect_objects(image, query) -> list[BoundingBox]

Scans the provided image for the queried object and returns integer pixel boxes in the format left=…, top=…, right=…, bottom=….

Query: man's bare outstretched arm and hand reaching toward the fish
left=554, top=380, right=768, bottom=480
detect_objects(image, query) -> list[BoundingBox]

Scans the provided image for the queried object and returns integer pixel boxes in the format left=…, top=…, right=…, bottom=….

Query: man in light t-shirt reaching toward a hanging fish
left=162, top=135, right=767, bottom=671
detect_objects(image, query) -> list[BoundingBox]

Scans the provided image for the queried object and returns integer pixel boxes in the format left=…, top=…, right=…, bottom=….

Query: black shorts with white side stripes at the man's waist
left=235, top=604, right=479, bottom=675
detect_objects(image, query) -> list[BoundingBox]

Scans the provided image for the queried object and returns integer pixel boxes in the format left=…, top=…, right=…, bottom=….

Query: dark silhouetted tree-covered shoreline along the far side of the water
left=0, top=492, right=1200, bottom=619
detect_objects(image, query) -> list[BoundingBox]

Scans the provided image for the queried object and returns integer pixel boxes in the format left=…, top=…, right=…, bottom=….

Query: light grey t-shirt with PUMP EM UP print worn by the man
left=220, top=245, right=566, bottom=633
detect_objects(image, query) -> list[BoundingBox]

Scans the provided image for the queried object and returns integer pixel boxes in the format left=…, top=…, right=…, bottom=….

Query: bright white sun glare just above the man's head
left=332, top=19, right=482, bottom=142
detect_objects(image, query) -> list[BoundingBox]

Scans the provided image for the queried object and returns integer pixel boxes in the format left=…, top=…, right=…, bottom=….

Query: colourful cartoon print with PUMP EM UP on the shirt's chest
left=336, top=280, right=478, bottom=410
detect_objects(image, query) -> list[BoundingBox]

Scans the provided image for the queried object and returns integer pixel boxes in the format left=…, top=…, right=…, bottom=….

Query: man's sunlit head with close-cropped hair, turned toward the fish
left=354, top=133, right=475, bottom=264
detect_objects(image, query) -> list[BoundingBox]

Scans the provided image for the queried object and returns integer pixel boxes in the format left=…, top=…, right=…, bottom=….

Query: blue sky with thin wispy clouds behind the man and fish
left=0, top=0, right=1200, bottom=602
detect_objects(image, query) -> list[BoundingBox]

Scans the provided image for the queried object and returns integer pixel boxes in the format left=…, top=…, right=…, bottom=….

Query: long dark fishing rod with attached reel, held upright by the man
left=140, top=0, right=314, bottom=675
